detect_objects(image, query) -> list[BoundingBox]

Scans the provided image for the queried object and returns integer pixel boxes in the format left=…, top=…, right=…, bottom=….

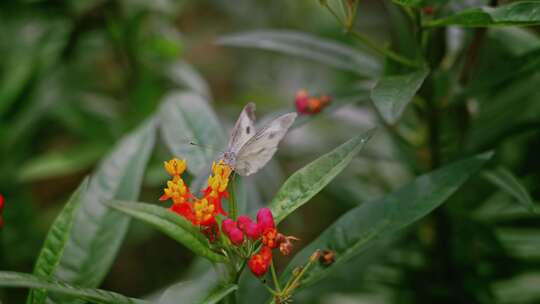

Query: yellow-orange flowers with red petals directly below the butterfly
left=159, top=158, right=232, bottom=228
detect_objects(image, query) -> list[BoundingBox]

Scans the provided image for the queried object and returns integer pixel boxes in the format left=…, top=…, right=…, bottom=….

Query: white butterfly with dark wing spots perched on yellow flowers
left=223, top=103, right=297, bottom=176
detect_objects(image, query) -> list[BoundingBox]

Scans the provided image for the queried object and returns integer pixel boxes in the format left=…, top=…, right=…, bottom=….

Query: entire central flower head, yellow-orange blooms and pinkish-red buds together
left=160, top=158, right=297, bottom=277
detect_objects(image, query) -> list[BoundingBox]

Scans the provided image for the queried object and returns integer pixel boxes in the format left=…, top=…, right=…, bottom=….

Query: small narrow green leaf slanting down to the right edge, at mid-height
left=483, top=167, right=538, bottom=213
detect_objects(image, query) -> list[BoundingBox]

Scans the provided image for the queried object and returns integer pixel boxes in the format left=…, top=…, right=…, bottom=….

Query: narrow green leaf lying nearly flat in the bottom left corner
left=0, top=271, right=149, bottom=304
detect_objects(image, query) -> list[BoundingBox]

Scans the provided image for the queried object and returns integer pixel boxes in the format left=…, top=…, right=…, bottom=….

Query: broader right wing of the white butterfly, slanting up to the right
left=234, top=113, right=297, bottom=176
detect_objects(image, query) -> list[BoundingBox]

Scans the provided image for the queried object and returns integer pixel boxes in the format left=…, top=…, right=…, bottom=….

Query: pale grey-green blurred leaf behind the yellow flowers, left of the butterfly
left=159, top=91, right=226, bottom=175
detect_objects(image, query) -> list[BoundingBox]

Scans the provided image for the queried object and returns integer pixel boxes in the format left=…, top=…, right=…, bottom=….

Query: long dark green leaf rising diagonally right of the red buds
left=282, top=153, right=492, bottom=286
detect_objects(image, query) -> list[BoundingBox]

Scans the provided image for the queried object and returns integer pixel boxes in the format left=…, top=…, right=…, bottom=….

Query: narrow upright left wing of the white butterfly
left=227, top=102, right=255, bottom=154
